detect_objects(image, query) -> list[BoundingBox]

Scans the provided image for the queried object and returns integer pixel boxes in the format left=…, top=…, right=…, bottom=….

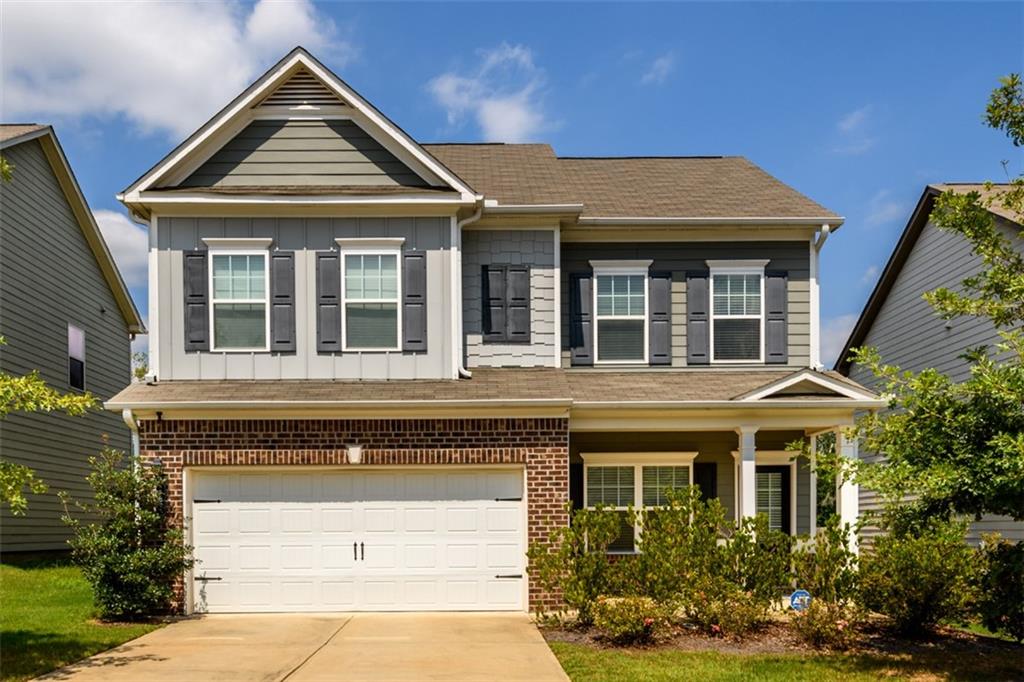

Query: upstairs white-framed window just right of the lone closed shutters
left=591, top=260, right=650, bottom=364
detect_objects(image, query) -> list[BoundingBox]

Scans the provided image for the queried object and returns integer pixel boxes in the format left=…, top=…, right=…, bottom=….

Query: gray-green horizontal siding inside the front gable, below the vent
left=178, top=120, right=427, bottom=187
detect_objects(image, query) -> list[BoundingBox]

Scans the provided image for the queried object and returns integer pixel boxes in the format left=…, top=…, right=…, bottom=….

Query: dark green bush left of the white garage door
left=62, top=447, right=195, bottom=620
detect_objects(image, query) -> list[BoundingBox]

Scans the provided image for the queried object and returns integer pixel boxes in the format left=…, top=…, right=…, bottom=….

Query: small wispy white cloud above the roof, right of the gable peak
left=427, top=43, right=552, bottom=142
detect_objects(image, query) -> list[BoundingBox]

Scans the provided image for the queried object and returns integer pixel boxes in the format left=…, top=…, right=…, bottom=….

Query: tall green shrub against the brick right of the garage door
left=526, top=501, right=620, bottom=626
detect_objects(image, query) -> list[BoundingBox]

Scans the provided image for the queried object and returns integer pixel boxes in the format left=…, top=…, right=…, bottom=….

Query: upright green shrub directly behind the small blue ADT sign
left=793, top=515, right=857, bottom=604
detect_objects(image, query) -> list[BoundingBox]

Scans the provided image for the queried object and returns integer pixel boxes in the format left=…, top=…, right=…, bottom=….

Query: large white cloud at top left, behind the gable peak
left=0, top=0, right=354, bottom=137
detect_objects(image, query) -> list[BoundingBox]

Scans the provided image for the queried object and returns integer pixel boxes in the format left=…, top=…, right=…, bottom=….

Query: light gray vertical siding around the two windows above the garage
left=151, top=217, right=454, bottom=380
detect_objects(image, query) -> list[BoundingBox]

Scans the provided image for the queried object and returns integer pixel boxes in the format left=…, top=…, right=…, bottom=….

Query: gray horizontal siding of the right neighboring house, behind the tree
left=850, top=218, right=1024, bottom=544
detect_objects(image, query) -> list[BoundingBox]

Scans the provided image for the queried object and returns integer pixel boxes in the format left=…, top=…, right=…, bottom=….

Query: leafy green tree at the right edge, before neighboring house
left=855, top=74, right=1024, bottom=530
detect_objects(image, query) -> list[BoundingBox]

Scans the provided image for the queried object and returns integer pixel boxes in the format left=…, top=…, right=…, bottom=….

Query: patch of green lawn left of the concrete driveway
left=0, top=561, right=160, bottom=682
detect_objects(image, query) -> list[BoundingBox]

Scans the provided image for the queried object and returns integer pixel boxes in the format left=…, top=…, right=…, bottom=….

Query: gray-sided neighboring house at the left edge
left=0, top=125, right=145, bottom=554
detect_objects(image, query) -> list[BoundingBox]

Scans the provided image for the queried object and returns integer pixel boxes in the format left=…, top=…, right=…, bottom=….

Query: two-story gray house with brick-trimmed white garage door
left=108, top=48, right=882, bottom=611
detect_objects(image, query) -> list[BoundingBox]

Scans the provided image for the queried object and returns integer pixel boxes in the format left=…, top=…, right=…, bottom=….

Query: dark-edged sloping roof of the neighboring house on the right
left=836, top=182, right=1024, bottom=374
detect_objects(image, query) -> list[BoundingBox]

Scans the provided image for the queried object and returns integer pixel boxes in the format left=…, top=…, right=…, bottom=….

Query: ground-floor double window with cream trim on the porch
left=583, top=453, right=696, bottom=553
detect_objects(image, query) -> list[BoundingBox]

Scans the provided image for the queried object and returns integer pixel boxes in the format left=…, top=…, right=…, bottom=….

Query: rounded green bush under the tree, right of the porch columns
left=860, top=520, right=976, bottom=634
